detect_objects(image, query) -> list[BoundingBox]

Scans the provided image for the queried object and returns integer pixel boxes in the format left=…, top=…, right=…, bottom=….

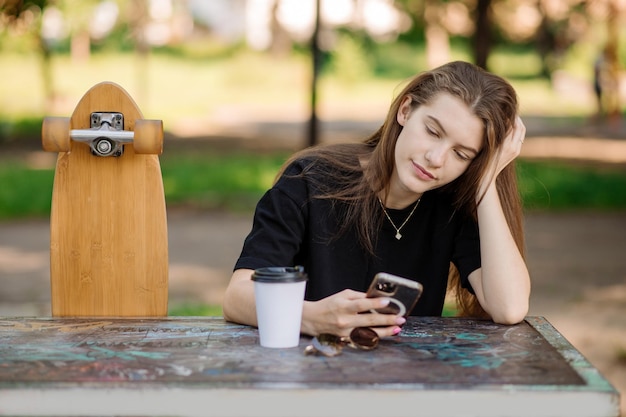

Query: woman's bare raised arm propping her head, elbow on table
left=469, top=117, right=530, bottom=324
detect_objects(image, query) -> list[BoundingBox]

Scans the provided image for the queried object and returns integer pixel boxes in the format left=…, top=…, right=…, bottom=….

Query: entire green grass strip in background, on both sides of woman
left=0, top=152, right=626, bottom=220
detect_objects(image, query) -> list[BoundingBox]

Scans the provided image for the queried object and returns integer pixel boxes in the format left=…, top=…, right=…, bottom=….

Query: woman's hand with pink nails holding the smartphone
left=301, top=290, right=406, bottom=337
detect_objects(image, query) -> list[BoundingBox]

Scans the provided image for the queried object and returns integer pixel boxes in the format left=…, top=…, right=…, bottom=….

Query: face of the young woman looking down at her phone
left=387, top=93, right=483, bottom=208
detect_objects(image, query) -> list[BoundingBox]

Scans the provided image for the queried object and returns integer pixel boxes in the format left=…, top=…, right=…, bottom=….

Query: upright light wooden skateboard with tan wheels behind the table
left=42, top=82, right=168, bottom=317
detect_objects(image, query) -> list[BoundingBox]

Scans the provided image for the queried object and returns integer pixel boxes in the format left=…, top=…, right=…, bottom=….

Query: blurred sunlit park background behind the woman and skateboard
left=0, top=0, right=626, bottom=413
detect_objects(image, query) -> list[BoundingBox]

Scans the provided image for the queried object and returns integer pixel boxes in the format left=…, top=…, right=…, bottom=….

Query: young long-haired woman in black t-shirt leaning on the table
left=223, top=62, right=530, bottom=337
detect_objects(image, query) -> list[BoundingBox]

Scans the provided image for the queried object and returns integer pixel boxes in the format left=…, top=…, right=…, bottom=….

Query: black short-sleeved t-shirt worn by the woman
left=234, top=160, right=480, bottom=316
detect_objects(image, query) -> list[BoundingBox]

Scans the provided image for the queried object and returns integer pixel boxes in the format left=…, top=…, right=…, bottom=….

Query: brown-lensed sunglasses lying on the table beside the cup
left=304, top=327, right=379, bottom=356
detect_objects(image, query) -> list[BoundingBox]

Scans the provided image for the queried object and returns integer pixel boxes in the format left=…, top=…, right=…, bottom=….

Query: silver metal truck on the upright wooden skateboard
left=70, top=112, right=135, bottom=156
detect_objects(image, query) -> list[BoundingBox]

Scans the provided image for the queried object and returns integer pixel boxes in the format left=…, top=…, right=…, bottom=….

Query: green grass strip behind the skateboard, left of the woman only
left=0, top=153, right=287, bottom=220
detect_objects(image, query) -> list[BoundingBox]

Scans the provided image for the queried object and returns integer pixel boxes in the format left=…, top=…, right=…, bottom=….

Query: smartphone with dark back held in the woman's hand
left=367, top=272, right=424, bottom=317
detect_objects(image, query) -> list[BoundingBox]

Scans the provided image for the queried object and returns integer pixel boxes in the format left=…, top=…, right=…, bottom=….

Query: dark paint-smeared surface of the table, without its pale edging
left=0, top=317, right=585, bottom=387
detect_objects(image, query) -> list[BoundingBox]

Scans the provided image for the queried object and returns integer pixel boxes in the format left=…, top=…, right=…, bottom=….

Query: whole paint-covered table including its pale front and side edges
left=0, top=317, right=619, bottom=417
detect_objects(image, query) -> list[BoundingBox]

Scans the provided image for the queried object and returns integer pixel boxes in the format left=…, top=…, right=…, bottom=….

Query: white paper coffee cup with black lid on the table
left=252, top=266, right=307, bottom=348
